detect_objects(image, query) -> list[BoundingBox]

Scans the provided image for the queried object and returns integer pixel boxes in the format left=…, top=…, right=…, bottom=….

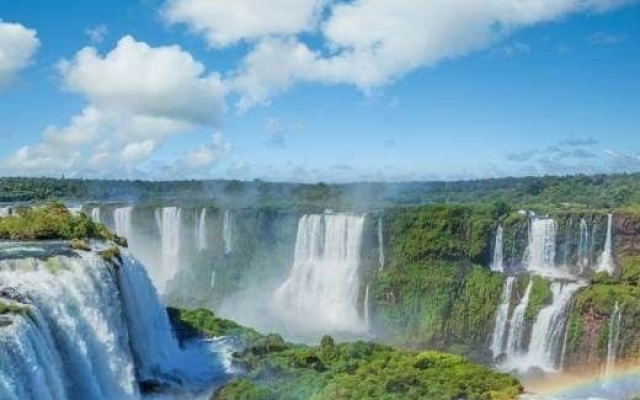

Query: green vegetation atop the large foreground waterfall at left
left=0, top=203, right=126, bottom=245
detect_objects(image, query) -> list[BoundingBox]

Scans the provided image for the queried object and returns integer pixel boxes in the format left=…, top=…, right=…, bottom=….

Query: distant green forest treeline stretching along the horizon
left=0, top=173, right=640, bottom=209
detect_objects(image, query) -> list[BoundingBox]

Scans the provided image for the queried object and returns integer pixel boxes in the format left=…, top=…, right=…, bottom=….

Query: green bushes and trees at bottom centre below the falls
left=170, top=310, right=522, bottom=400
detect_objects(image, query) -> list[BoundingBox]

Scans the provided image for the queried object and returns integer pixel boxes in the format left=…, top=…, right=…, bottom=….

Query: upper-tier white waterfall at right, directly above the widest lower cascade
left=525, top=218, right=558, bottom=275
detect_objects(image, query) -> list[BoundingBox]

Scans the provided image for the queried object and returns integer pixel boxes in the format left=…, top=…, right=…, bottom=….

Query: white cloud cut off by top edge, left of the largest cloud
left=162, top=0, right=327, bottom=47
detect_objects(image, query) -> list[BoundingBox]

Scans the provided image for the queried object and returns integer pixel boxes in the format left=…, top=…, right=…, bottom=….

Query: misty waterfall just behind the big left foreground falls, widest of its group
left=155, top=207, right=182, bottom=294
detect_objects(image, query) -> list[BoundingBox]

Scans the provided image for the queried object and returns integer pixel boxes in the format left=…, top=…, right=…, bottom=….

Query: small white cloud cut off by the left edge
left=0, top=19, right=40, bottom=89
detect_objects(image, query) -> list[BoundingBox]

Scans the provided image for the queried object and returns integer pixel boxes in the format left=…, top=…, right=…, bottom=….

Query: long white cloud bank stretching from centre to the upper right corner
left=226, top=0, right=630, bottom=109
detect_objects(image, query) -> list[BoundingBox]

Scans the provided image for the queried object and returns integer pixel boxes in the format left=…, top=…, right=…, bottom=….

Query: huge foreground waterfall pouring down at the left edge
left=0, top=245, right=225, bottom=400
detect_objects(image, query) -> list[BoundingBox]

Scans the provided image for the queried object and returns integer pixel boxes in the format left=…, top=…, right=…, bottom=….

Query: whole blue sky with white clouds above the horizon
left=0, top=0, right=640, bottom=181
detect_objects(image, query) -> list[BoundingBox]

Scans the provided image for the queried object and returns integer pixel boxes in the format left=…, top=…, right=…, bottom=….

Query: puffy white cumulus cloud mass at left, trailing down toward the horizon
left=1, top=36, right=225, bottom=174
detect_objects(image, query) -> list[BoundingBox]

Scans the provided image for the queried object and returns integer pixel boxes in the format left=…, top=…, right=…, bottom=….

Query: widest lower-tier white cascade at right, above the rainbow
left=515, top=282, right=584, bottom=372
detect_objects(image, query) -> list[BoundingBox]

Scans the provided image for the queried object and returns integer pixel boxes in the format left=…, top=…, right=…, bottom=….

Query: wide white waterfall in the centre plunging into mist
left=274, top=213, right=366, bottom=333
